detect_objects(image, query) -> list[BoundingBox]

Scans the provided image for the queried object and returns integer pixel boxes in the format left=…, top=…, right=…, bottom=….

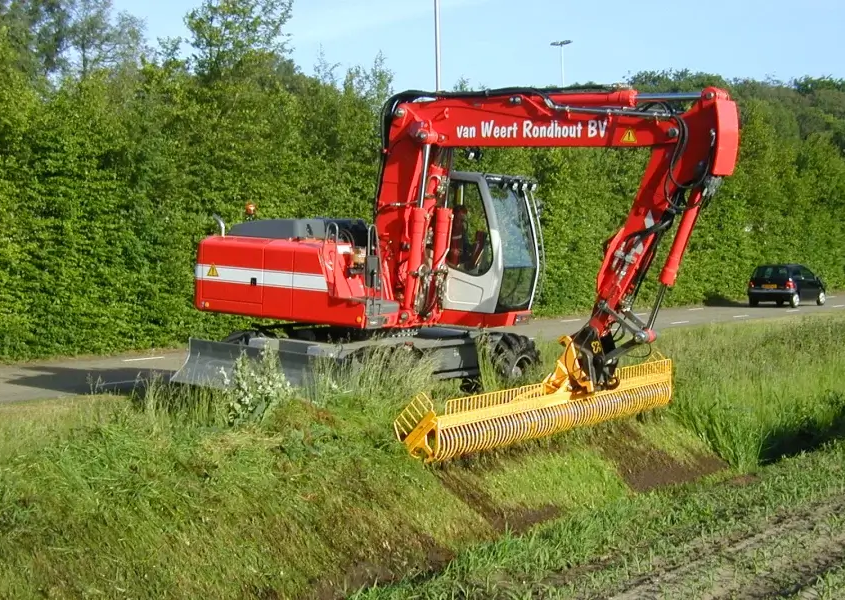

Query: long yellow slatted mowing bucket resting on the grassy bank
left=394, top=359, right=672, bottom=463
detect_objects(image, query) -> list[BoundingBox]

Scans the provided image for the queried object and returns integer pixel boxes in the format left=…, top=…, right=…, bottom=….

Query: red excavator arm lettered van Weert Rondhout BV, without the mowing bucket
left=376, top=83, right=739, bottom=393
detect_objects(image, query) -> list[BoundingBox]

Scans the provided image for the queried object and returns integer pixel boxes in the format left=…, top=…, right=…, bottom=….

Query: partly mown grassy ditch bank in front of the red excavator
left=0, top=316, right=845, bottom=598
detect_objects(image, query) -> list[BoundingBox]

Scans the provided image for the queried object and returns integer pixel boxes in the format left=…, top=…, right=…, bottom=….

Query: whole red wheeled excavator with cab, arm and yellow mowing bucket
left=172, top=82, right=739, bottom=461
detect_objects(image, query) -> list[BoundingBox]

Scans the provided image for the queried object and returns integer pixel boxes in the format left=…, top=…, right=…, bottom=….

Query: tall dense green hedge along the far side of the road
left=0, top=17, right=845, bottom=360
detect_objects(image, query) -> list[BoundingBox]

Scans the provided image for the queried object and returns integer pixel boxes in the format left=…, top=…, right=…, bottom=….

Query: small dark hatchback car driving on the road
left=748, top=263, right=825, bottom=308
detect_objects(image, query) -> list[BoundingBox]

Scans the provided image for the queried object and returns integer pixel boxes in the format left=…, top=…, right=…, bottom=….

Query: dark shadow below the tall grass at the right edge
left=760, top=392, right=845, bottom=465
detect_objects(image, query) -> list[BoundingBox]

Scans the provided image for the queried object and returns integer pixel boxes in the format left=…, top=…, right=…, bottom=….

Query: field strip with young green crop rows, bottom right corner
left=352, top=440, right=845, bottom=600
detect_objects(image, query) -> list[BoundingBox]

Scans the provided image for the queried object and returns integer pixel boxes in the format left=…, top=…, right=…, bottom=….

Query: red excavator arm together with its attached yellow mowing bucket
left=390, top=87, right=739, bottom=461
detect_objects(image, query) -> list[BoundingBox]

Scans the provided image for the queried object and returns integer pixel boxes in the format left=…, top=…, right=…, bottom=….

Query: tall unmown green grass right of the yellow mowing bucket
left=663, top=315, right=845, bottom=469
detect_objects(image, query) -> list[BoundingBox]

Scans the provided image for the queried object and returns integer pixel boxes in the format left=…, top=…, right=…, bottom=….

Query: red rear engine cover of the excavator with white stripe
left=194, top=219, right=390, bottom=328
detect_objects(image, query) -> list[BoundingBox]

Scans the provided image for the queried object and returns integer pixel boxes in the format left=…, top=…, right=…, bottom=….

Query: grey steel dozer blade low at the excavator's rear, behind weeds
left=170, top=338, right=310, bottom=389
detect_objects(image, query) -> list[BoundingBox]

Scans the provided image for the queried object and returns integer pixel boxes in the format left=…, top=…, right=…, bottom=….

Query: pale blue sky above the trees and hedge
left=113, top=0, right=845, bottom=91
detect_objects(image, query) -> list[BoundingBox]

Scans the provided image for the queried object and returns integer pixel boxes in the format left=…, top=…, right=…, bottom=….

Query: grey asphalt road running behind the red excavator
left=0, top=292, right=845, bottom=403
